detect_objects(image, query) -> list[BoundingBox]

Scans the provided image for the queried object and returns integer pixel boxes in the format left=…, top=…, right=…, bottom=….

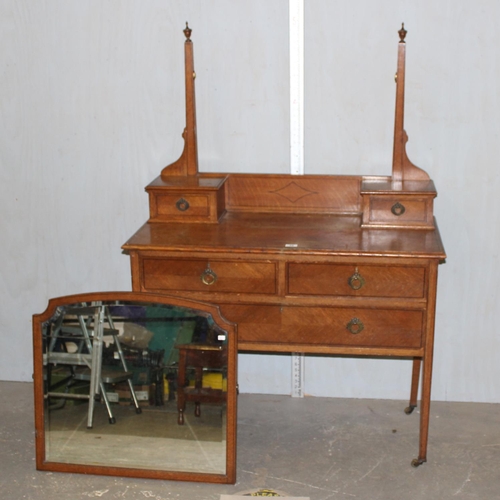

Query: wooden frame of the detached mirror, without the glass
left=33, top=292, right=237, bottom=484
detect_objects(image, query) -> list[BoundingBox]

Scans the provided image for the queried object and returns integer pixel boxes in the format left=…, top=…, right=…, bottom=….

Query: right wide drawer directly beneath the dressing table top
left=288, top=262, right=425, bottom=298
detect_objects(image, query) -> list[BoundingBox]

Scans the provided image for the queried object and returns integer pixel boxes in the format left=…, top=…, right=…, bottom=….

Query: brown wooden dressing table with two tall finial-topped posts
left=123, top=26, right=446, bottom=466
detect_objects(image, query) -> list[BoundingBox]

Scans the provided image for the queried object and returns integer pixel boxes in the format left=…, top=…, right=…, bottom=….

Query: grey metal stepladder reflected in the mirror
left=44, top=305, right=141, bottom=428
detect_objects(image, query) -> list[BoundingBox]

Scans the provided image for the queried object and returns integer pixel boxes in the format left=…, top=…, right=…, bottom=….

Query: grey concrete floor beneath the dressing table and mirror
left=0, top=382, right=500, bottom=500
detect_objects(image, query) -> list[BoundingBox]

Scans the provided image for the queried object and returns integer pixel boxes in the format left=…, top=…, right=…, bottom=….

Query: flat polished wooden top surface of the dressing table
left=123, top=212, right=446, bottom=259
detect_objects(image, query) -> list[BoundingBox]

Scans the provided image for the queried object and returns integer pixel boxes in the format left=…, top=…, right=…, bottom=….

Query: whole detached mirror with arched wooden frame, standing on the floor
left=33, top=293, right=236, bottom=482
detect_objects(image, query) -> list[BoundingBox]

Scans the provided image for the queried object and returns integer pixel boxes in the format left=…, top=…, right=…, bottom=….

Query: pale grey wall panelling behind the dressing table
left=0, top=0, right=500, bottom=402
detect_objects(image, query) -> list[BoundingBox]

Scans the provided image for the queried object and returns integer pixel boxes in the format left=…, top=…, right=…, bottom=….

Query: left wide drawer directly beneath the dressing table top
left=142, top=258, right=276, bottom=294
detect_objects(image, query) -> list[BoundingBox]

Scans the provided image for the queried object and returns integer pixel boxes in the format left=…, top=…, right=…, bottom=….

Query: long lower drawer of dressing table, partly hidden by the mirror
left=220, top=304, right=423, bottom=348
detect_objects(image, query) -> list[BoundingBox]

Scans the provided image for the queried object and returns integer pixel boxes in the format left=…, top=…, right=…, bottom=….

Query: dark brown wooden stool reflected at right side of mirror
left=175, top=344, right=227, bottom=425
